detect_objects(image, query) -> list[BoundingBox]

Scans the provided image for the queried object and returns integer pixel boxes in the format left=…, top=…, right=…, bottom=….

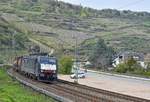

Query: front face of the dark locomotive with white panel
left=38, top=56, right=58, bottom=81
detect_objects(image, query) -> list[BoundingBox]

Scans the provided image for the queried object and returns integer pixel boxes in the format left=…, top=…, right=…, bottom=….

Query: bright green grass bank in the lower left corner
left=0, top=69, right=55, bottom=102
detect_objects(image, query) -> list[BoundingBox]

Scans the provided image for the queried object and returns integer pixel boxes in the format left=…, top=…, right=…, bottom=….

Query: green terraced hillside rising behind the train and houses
left=0, top=0, right=150, bottom=63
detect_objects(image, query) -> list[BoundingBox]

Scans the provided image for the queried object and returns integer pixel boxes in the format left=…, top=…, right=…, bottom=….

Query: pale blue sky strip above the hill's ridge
left=60, top=0, right=150, bottom=12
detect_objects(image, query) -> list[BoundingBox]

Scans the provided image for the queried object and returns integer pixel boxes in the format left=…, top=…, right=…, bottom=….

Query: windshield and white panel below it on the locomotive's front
left=40, top=58, right=56, bottom=70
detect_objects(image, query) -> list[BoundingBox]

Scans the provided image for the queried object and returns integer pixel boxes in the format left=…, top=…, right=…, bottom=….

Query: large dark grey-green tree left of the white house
left=89, top=38, right=114, bottom=68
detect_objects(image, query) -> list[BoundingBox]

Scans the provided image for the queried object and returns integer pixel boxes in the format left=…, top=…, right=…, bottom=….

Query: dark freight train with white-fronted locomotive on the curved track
left=13, top=53, right=58, bottom=82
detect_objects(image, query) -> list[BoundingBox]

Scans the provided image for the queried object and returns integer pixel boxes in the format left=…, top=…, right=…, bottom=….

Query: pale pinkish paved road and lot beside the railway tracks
left=59, top=69, right=150, bottom=99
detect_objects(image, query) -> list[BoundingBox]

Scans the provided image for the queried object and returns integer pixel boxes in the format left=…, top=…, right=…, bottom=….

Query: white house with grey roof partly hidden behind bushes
left=112, top=51, right=146, bottom=68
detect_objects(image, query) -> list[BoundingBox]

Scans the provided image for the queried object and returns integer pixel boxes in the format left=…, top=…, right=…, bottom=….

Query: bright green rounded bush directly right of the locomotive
left=59, top=56, right=73, bottom=74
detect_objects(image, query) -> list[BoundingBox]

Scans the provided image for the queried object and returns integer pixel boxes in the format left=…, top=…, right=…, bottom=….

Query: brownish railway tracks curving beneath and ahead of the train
left=8, top=69, right=150, bottom=102
